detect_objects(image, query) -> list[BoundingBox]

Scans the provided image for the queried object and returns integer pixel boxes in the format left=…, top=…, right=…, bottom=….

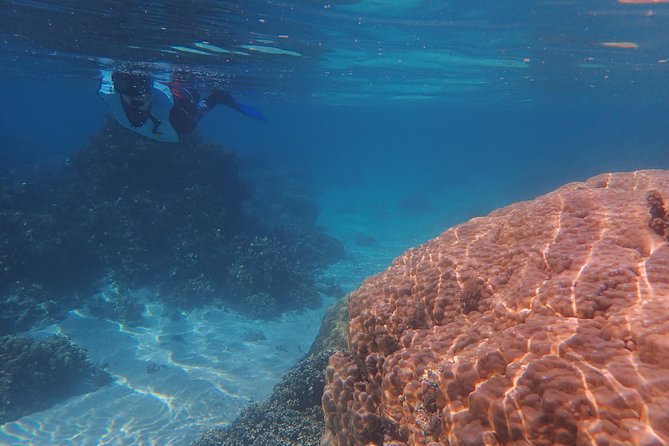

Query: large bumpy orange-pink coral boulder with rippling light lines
left=323, top=171, right=669, bottom=446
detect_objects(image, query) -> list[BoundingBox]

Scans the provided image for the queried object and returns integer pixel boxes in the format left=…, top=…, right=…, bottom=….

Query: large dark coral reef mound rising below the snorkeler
left=0, top=120, right=343, bottom=333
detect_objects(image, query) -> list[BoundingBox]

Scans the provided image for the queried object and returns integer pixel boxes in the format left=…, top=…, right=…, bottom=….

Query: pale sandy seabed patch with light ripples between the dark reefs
left=0, top=299, right=332, bottom=445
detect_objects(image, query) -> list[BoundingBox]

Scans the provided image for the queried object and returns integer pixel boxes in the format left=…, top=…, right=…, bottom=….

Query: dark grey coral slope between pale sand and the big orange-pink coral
left=192, top=298, right=348, bottom=446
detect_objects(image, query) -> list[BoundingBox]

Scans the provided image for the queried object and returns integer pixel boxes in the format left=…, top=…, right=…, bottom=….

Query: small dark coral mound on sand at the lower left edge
left=0, top=336, right=111, bottom=424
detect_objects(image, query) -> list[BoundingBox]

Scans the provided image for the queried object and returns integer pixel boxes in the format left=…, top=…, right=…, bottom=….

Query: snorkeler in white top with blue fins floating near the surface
left=98, top=70, right=265, bottom=142
